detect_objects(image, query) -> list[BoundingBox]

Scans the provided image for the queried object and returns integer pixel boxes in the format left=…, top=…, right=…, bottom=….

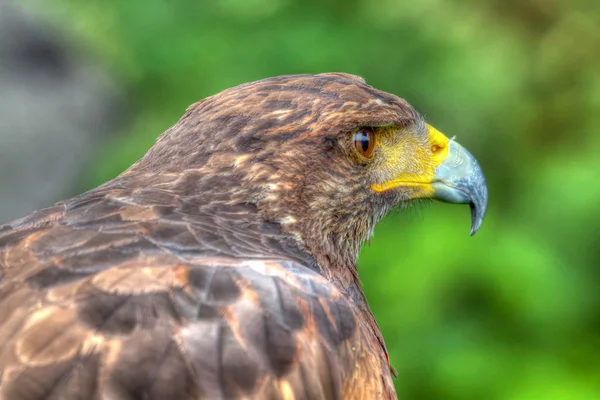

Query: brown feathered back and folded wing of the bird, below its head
left=0, top=190, right=391, bottom=400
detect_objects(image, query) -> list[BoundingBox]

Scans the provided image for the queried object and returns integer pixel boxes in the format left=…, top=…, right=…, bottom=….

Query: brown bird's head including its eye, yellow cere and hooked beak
left=132, top=73, right=487, bottom=274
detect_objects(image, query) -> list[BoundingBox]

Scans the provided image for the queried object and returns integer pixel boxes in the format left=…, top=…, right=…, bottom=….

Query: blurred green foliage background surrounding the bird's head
left=14, top=0, right=600, bottom=400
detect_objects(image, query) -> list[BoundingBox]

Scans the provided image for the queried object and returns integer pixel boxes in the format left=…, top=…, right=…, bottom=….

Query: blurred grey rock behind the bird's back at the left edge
left=0, top=0, right=122, bottom=224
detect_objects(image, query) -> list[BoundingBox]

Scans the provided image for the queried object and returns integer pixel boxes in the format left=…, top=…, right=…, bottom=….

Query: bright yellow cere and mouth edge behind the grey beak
left=371, top=124, right=449, bottom=198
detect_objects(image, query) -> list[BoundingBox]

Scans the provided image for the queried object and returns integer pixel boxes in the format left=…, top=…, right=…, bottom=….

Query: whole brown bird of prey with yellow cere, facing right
left=0, top=73, right=487, bottom=400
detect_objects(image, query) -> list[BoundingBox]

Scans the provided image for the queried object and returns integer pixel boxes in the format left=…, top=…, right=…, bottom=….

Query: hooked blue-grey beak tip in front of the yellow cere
left=432, top=141, right=487, bottom=236
